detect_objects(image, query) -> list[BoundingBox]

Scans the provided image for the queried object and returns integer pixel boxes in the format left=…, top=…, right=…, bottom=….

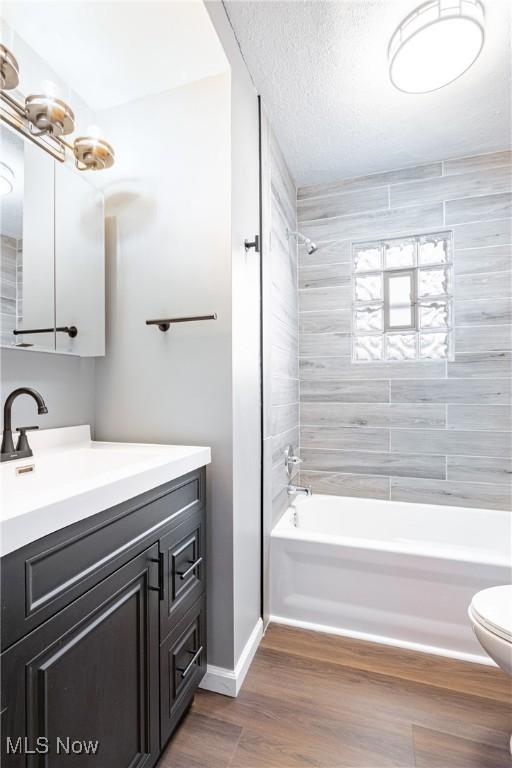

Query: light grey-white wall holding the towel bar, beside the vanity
left=92, top=74, right=233, bottom=668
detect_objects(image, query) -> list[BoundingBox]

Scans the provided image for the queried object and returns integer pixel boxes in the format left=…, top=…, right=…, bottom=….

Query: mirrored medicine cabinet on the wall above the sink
left=0, top=125, right=105, bottom=356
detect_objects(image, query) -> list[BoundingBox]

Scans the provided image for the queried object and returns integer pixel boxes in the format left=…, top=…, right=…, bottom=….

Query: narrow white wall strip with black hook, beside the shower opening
left=206, top=2, right=262, bottom=665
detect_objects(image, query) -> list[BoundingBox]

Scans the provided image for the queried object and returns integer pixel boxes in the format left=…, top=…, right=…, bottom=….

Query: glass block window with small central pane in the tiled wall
left=352, top=232, right=453, bottom=362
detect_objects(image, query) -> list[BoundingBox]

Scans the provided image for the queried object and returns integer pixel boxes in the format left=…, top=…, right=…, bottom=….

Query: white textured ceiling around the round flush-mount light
left=225, top=0, right=511, bottom=185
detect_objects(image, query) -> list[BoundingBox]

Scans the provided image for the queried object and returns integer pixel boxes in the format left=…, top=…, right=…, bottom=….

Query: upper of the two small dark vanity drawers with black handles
left=160, top=507, right=206, bottom=637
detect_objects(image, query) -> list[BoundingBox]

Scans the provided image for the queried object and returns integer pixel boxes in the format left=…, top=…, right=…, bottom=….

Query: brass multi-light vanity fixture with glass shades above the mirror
left=0, top=45, right=115, bottom=170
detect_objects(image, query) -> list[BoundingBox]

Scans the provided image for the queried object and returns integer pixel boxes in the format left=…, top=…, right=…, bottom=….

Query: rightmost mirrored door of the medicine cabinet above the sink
left=55, top=163, right=105, bottom=357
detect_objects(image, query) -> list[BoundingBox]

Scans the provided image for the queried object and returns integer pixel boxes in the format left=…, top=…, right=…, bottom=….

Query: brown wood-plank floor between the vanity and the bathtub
left=158, top=625, right=512, bottom=768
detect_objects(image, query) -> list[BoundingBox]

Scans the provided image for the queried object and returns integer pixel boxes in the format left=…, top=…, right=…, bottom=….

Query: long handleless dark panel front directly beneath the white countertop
left=1, top=469, right=205, bottom=648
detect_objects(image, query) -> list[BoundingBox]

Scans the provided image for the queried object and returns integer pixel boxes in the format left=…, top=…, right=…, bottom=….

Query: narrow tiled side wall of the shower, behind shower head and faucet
left=262, top=121, right=300, bottom=524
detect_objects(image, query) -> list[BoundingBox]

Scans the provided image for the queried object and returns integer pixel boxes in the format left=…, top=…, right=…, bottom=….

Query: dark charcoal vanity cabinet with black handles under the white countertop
left=1, top=469, right=206, bottom=768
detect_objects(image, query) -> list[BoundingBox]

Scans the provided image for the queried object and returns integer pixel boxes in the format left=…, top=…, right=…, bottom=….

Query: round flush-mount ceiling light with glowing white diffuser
left=388, top=0, right=485, bottom=93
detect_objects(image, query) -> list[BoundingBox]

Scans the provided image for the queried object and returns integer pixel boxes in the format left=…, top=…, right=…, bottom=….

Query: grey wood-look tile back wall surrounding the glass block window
left=298, top=151, right=512, bottom=509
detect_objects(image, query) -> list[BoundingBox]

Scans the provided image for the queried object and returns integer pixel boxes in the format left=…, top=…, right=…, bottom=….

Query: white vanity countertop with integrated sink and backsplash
left=0, top=426, right=211, bottom=555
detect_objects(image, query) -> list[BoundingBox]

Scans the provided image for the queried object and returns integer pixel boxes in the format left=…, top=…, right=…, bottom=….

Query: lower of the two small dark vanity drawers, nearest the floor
left=160, top=596, right=206, bottom=747
